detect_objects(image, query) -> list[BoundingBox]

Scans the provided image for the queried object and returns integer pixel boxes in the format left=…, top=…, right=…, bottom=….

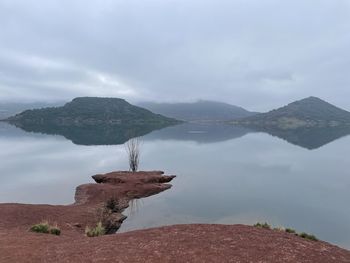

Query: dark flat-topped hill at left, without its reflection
left=7, top=97, right=179, bottom=126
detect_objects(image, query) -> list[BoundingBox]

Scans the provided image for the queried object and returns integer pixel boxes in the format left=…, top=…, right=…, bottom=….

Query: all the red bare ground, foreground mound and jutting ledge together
left=0, top=172, right=350, bottom=263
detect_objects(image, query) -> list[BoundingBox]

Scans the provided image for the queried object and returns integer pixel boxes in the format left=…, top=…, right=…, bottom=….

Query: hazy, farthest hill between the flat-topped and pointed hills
left=138, top=100, right=256, bottom=121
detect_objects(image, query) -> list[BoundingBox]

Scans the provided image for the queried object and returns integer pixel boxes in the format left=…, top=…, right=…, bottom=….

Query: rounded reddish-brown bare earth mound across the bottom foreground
left=0, top=225, right=350, bottom=263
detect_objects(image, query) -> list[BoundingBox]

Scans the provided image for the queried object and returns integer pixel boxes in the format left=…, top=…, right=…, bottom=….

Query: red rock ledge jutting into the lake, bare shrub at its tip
left=0, top=171, right=175, bottom=235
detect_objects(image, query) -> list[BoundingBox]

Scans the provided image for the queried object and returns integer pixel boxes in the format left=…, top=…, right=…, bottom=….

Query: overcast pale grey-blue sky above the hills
left=0, top=0, right=350, bottom=111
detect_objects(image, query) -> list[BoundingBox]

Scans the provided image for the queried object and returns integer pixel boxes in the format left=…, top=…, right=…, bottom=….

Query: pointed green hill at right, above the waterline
left=234, top=97, right=350, bottom=129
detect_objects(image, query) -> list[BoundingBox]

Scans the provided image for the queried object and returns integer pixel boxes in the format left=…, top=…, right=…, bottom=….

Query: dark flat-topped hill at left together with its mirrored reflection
left=6, top=97, right=181, bottom=145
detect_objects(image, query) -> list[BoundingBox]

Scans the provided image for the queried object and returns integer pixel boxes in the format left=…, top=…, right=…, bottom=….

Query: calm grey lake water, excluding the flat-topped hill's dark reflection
left=0, top=123, right=350, bottom=248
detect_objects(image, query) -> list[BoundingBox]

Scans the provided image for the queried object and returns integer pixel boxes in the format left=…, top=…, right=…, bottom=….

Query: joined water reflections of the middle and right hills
left=145, top=123, right=350, bottom=150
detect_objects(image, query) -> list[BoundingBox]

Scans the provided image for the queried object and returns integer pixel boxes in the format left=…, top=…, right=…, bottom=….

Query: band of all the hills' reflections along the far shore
left=0, top=120, right=350, bottom=150
